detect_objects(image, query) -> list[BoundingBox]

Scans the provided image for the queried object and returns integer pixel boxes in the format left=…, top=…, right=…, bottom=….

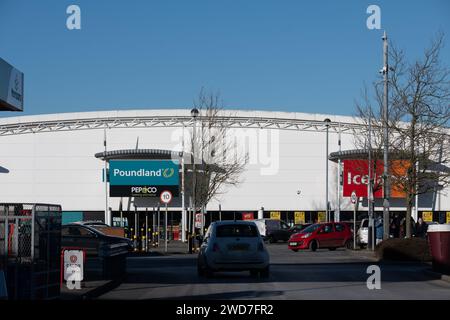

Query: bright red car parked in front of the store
left=288, top=222, right=353, bottom=252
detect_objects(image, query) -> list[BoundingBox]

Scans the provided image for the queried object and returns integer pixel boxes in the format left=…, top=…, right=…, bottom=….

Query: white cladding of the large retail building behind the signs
left=0, top=110, right=450, bottom=211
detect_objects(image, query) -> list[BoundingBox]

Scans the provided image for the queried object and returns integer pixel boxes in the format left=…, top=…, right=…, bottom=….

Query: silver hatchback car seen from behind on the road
left=197, top=220, right=270, bottom=278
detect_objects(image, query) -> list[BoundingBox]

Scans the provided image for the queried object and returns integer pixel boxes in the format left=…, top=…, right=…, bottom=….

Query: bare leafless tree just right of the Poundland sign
left=188, top=89, right=248, bottom=216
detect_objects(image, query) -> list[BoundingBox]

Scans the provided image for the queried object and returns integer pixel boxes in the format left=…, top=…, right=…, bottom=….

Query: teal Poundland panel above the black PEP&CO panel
left=109, top=160, right=179, bottom=186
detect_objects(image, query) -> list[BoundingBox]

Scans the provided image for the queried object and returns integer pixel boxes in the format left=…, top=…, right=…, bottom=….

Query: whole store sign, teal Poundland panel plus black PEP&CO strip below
left=109, top=160, right=179, bottom=197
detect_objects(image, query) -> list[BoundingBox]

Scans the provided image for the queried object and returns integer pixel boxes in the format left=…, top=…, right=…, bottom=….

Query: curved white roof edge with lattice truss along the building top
left=0, top=109, right=365, bottom=136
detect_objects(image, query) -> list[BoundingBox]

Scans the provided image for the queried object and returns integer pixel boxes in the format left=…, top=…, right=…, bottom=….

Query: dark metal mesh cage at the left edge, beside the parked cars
left=0, top=203, right=61, bottom=299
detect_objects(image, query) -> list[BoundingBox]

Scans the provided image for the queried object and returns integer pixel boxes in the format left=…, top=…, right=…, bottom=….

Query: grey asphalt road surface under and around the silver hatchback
left=95, top=243, right=450, bottom=300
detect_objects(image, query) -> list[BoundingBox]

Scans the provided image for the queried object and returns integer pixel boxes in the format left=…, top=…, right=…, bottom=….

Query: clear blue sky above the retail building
left=0, top=0, right=450, bottom=117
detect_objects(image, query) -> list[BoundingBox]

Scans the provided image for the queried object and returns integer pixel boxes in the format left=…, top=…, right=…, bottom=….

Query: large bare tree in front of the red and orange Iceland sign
left=356, top=34, right=450, bottom=237
